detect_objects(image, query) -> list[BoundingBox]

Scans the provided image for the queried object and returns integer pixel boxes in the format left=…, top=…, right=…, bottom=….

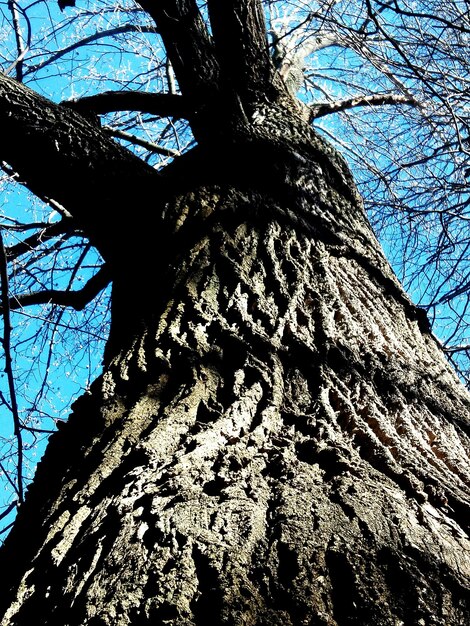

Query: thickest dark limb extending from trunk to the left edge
left=0, top=75, right=159, bottom=260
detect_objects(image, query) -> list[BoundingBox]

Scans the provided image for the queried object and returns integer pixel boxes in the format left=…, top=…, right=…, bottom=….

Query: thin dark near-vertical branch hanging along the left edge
left=0, top=229, right=24, bottom=503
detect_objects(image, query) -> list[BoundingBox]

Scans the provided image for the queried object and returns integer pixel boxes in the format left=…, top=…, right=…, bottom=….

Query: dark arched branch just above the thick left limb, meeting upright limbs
left=62, top=91, right=192, bottom=119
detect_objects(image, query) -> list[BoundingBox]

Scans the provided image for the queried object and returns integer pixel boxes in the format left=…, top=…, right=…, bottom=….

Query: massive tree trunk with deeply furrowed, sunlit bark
left=1, top=102, right=470, bottom=626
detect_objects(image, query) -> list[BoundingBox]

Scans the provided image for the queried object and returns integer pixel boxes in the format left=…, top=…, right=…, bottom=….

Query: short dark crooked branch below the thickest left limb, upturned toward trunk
left=9, top=265, right=111, bottom=311
